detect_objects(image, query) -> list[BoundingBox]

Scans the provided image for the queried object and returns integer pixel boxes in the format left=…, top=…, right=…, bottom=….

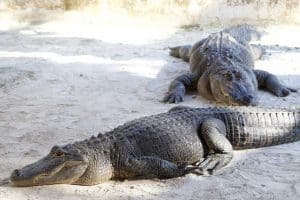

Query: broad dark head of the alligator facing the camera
left=209, top=66, right=257, bottom=106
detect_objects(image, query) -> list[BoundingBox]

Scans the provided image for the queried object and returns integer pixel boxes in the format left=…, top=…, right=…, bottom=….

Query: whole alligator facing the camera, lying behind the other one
left=163, top=24, right=297, bottom=106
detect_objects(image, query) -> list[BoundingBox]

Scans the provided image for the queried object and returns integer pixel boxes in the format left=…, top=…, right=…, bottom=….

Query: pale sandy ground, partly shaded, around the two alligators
left=0, top=21, right=300, bottom=200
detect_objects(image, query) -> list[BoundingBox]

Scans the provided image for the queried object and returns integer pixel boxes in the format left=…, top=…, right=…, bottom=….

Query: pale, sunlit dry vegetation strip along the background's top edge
left=5, top=0, right=300, bottom=25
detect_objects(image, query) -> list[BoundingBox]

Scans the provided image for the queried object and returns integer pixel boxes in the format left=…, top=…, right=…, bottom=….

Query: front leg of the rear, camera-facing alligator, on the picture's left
left=163, top=73, right=198, bottom=103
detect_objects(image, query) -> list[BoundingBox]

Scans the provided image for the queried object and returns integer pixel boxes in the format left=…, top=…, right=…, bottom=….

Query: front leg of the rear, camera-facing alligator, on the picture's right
left=254, top=70, right=297, bottom=97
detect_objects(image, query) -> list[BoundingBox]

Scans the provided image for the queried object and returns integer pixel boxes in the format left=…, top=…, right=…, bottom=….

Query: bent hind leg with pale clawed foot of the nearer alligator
left=192, top=118, right=233, bottom=175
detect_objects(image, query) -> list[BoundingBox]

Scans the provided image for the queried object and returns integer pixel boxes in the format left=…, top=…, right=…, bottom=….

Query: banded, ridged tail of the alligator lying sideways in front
left=227, top=107, right=300, bottom=149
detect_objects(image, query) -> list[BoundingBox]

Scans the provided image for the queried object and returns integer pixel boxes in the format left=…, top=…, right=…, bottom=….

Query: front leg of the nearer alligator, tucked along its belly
left=124, top=156, right=187, bottom=178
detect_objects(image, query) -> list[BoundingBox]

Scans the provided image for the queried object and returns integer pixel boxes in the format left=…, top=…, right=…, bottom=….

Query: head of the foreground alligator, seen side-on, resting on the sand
left=10, top=145, right=88, bottom=186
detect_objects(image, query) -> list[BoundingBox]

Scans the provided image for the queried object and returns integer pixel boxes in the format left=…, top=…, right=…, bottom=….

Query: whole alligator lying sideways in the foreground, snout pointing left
left=10, top=106, right=300, bottom=186
